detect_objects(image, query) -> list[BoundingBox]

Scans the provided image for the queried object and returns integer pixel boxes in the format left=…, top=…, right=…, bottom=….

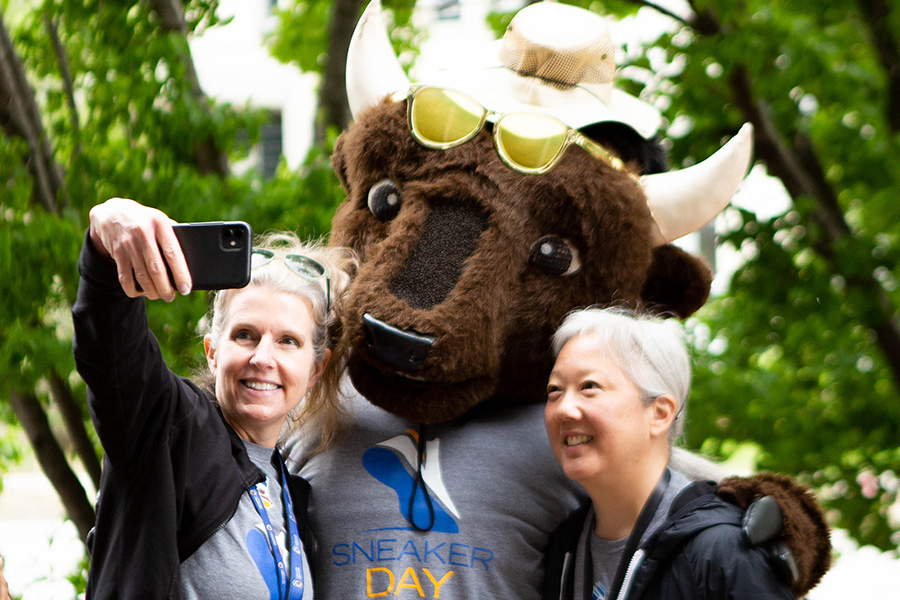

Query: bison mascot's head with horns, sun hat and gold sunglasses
left=331, top=0, right=751, bottom=423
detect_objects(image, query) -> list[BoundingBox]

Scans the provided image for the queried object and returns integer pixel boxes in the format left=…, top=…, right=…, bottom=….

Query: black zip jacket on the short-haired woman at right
left=542, top=482, right=794, bottom=600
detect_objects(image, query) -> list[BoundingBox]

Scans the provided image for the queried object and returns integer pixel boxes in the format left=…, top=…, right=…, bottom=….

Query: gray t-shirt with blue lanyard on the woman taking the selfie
left=176, top=442, right=313, bottom=600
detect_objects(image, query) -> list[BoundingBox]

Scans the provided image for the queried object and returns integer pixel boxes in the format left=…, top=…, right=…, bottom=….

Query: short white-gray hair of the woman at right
left=551, top=308, right=691, bottom=440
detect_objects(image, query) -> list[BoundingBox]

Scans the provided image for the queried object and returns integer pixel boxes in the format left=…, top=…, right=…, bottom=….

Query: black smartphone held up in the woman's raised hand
left=170, top=221, right=253, bottom=290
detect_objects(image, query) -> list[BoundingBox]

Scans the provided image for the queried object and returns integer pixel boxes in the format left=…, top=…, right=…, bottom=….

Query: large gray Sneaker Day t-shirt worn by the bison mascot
left=286, top=386, right=586, bottom=600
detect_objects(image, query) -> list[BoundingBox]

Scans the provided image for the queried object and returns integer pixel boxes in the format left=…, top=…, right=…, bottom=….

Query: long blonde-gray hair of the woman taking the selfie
left=199, top=232, right=358, bottom=450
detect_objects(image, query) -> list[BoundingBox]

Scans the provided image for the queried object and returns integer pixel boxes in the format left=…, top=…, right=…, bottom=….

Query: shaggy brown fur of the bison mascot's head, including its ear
left=332, top=100, right=710, bottom=423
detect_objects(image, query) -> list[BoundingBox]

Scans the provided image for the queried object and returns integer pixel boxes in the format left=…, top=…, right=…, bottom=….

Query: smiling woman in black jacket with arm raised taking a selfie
left=73, top=199, right=355, bottom=600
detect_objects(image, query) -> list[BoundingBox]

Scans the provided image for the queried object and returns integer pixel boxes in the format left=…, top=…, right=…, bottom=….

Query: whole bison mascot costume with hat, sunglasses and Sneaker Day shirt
left=290, top=0, right=829, bottom=600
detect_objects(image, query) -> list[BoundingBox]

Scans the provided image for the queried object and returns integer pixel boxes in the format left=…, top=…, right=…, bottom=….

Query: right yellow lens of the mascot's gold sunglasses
left=494, top=113, right=568, bottom=171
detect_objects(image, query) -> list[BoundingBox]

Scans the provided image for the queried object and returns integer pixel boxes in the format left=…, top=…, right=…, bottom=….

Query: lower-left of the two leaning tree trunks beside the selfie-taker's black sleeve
left=9, top=390, right=94, bottom=541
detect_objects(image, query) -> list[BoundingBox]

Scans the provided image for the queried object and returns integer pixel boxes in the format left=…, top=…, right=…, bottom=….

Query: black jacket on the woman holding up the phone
left=72, top=236, right=315, bottom=599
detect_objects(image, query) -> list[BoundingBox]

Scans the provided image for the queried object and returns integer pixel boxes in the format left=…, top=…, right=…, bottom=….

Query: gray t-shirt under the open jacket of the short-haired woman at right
left=572, top=471, right=691, bottom=600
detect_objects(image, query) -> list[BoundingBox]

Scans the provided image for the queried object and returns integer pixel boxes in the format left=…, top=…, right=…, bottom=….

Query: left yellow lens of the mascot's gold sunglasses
left=409, top=88, right=485, bottom=147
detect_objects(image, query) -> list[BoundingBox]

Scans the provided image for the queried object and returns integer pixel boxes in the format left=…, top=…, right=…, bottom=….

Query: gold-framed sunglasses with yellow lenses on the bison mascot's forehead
left=406, top=84, right=623, bottom=174
